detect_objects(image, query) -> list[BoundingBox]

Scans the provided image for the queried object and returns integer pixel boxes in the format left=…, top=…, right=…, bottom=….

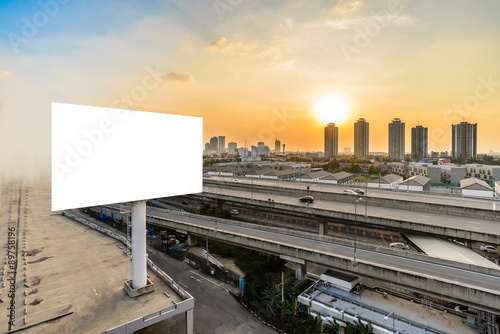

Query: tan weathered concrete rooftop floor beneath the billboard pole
left=0, top=183, right=181, bottom=333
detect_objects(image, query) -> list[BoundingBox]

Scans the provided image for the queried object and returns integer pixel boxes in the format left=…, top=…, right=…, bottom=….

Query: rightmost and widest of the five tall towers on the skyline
left=451, top=122, right=477, bottom=158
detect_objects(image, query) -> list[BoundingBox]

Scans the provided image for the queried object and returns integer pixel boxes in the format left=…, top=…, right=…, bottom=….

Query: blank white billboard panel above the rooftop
left=52, top=103, right=203, bottom=211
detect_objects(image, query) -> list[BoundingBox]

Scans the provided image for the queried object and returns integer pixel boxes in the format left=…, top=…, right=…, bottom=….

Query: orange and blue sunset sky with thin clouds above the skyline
left=0, top=0, right=500, bottom=175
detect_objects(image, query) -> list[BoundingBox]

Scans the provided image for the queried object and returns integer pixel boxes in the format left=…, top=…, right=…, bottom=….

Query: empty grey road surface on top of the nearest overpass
left=144, top=210, right=500, bottom=295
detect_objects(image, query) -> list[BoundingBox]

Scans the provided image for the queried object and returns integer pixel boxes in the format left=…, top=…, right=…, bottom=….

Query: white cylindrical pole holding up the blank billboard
left=132, top=201, right=147, bottom=289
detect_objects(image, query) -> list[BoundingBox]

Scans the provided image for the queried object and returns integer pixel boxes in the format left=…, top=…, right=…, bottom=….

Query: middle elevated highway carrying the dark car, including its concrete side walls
left=196, top=180, right=500, bottom=245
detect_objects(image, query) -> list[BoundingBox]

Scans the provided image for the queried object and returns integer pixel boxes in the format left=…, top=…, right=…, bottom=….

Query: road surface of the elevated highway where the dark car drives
left=203, top=185, right=500, bottom=235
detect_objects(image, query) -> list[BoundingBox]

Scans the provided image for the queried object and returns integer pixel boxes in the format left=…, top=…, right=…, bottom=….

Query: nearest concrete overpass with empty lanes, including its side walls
left=93, top=209, right=500, bottom=314
